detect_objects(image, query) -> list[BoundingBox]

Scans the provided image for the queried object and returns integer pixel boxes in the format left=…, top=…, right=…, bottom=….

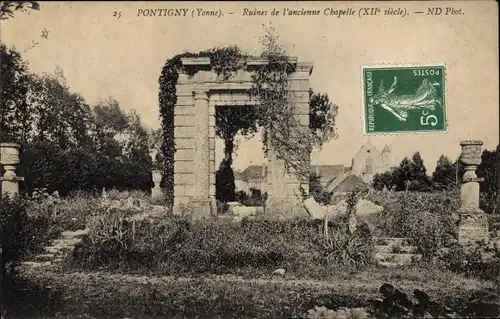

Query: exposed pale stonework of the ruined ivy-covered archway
left=174, top=58, right=313, bottom=218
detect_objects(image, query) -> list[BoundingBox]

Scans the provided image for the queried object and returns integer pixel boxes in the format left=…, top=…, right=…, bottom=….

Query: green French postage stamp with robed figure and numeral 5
left=362, top=65, right=447, bottom=134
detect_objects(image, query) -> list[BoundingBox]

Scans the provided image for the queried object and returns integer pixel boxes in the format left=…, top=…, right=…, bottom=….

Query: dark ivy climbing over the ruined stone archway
left=159, top=28, right=337, bottom=205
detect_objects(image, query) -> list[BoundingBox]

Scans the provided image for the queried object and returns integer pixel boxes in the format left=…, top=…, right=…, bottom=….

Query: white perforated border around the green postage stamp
left=359, top=61, right=450, bottom=136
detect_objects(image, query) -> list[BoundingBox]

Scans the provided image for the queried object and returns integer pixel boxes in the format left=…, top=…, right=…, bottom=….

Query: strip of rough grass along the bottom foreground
left=0, top=267, right=493, bottom=319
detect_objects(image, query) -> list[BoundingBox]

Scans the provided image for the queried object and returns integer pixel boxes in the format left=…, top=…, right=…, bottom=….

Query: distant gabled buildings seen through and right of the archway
left=234, top=142, right=395, bottom=193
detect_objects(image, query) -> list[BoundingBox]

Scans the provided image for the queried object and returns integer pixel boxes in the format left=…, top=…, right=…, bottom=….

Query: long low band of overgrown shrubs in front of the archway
left=73, top=215, right=373, bottom=277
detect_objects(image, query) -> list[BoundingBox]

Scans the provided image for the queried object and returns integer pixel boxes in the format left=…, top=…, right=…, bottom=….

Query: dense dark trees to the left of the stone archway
left=0, top=43, right=152, bottom=196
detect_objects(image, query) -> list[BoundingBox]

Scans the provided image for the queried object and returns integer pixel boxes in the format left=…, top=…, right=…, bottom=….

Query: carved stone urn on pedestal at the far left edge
left=0, top=143, right=24, bottom=196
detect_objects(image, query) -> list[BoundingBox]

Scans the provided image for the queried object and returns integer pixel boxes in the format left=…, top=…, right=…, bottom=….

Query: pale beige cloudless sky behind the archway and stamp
left=0, top=1, right=499, bottom=171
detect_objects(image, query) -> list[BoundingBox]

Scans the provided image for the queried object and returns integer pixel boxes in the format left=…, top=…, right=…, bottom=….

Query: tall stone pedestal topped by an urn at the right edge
left=458, top=141, right=489, bottom=245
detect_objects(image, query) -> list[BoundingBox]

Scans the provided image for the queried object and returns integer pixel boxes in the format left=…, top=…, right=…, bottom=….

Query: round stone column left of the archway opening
left=193, top=90, right=213, bottom=216
